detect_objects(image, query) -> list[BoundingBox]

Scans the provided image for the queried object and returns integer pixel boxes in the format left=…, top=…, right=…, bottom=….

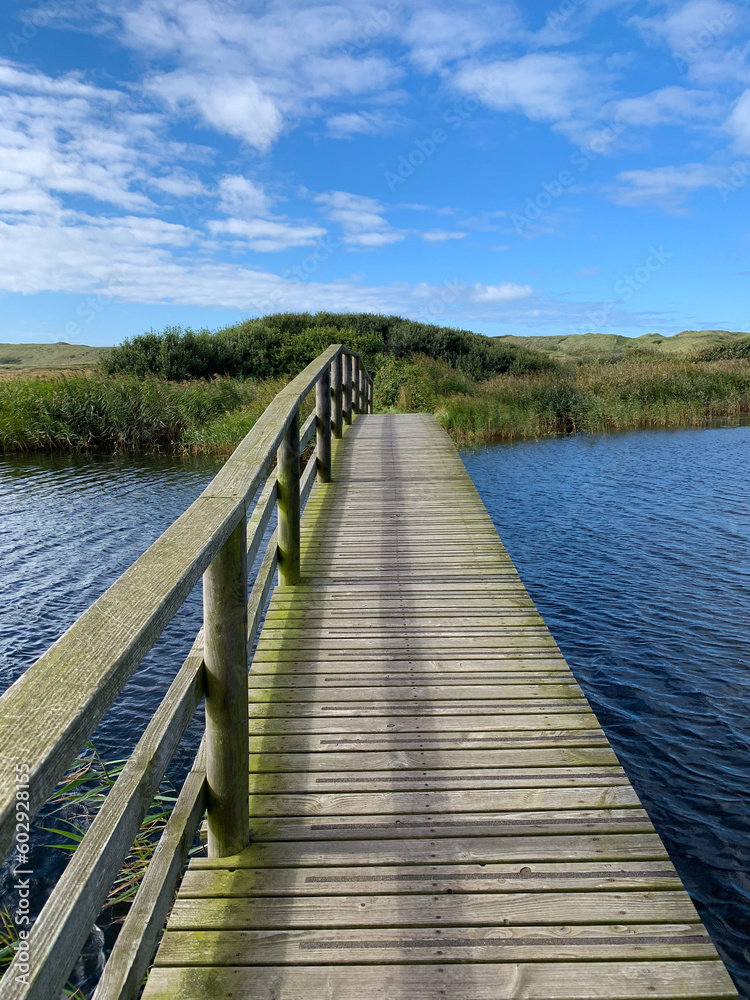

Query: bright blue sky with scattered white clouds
left=0, top=0, right=750, bottom=344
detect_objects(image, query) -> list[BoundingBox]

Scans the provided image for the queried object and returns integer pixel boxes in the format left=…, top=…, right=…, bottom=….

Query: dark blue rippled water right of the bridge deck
left=463, top=427, right=750, bottom=997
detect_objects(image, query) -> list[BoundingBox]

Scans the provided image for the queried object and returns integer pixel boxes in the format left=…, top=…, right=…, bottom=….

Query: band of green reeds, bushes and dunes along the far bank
left=0, top=313, right=750, bottom=456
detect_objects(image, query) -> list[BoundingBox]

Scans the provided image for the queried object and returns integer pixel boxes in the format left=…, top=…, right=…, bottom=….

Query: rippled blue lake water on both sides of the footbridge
left=0, top=427, right=750, bottom=998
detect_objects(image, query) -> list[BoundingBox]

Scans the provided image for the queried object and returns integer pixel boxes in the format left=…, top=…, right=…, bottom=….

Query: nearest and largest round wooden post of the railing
left=203, top=517, right=250, bottom=858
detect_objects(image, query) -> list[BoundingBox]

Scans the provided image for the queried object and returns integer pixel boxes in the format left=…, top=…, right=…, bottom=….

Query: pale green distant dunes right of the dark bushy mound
left=500, top=330, right=748, bottom=361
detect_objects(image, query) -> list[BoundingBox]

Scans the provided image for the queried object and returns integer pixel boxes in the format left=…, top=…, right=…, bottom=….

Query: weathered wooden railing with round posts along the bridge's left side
left=0, top=345, right=373, bottom=1000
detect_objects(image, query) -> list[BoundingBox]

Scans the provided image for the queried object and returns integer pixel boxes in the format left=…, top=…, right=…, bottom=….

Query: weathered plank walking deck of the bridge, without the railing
left=145, top=415, right=736, bottom=1000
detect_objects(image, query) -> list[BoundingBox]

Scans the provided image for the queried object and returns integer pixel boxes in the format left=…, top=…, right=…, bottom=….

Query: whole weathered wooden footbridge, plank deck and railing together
left=0, top=346, right=737, bottom=1000
